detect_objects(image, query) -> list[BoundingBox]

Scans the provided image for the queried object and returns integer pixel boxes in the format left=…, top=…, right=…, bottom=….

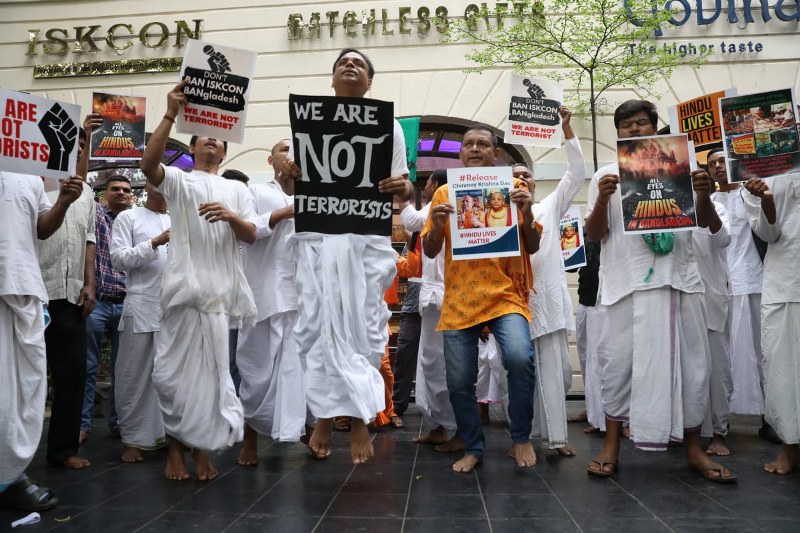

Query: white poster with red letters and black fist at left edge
left=0, top=88, right=81, bottom=179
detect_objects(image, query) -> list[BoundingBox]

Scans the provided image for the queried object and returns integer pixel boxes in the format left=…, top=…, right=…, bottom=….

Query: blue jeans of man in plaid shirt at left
left=81, top=300, right=122, bottom=431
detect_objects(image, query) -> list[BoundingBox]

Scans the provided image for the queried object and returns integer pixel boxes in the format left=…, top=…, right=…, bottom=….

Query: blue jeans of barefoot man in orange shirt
left=442, top=313, right=536, bottom=457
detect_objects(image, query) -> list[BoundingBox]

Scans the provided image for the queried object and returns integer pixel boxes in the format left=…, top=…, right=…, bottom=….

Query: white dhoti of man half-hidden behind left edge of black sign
left=236, top=311, right=306, bottom=442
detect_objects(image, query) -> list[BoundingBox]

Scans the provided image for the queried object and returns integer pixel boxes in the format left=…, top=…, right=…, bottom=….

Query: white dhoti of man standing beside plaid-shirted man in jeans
left=114, top=324, right=164, bottom=450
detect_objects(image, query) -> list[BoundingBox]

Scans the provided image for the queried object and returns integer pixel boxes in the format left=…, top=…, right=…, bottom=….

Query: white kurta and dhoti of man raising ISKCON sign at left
left=153, top=167, right=256, bottom=450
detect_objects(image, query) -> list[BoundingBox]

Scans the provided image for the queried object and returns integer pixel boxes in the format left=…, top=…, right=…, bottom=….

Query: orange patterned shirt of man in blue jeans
left=422, top=179, right=533, bottom=331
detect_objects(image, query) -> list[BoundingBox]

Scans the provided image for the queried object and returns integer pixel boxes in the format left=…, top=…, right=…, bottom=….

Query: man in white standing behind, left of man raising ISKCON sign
left=110, top=183, right=171, bottom=463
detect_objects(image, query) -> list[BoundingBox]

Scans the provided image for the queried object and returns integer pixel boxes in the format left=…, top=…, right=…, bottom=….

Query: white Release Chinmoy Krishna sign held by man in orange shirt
left=447, top=167, right=520, bottom=259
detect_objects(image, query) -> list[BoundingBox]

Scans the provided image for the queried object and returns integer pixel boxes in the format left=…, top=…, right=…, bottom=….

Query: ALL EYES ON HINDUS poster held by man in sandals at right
left=617, top=134, right=697, bottom=233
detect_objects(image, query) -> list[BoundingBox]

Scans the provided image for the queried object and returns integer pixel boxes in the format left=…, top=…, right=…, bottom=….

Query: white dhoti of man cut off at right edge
left=761, top=302, right=800, bottom=444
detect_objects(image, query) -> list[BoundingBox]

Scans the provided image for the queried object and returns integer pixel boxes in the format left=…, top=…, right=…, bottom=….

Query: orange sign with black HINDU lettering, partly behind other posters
left=667, top=89, right=736, bottom=148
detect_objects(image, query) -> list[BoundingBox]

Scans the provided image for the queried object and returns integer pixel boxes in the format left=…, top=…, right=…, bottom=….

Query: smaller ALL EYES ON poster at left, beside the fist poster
left=89, top=93, right=145, bottom=161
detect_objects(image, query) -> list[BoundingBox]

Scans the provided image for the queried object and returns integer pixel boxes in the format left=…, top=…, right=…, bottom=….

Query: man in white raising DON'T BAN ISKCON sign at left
left=141, top=78, right=256, bottom=481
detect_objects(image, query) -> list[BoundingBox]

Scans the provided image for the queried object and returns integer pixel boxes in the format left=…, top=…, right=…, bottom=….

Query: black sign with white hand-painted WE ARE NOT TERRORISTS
left=289, top=94, right=394, bottom=236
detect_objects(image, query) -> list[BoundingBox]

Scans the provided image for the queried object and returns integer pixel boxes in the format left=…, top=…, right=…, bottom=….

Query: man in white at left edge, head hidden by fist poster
left=0, top=172, right=83, bottom=511
